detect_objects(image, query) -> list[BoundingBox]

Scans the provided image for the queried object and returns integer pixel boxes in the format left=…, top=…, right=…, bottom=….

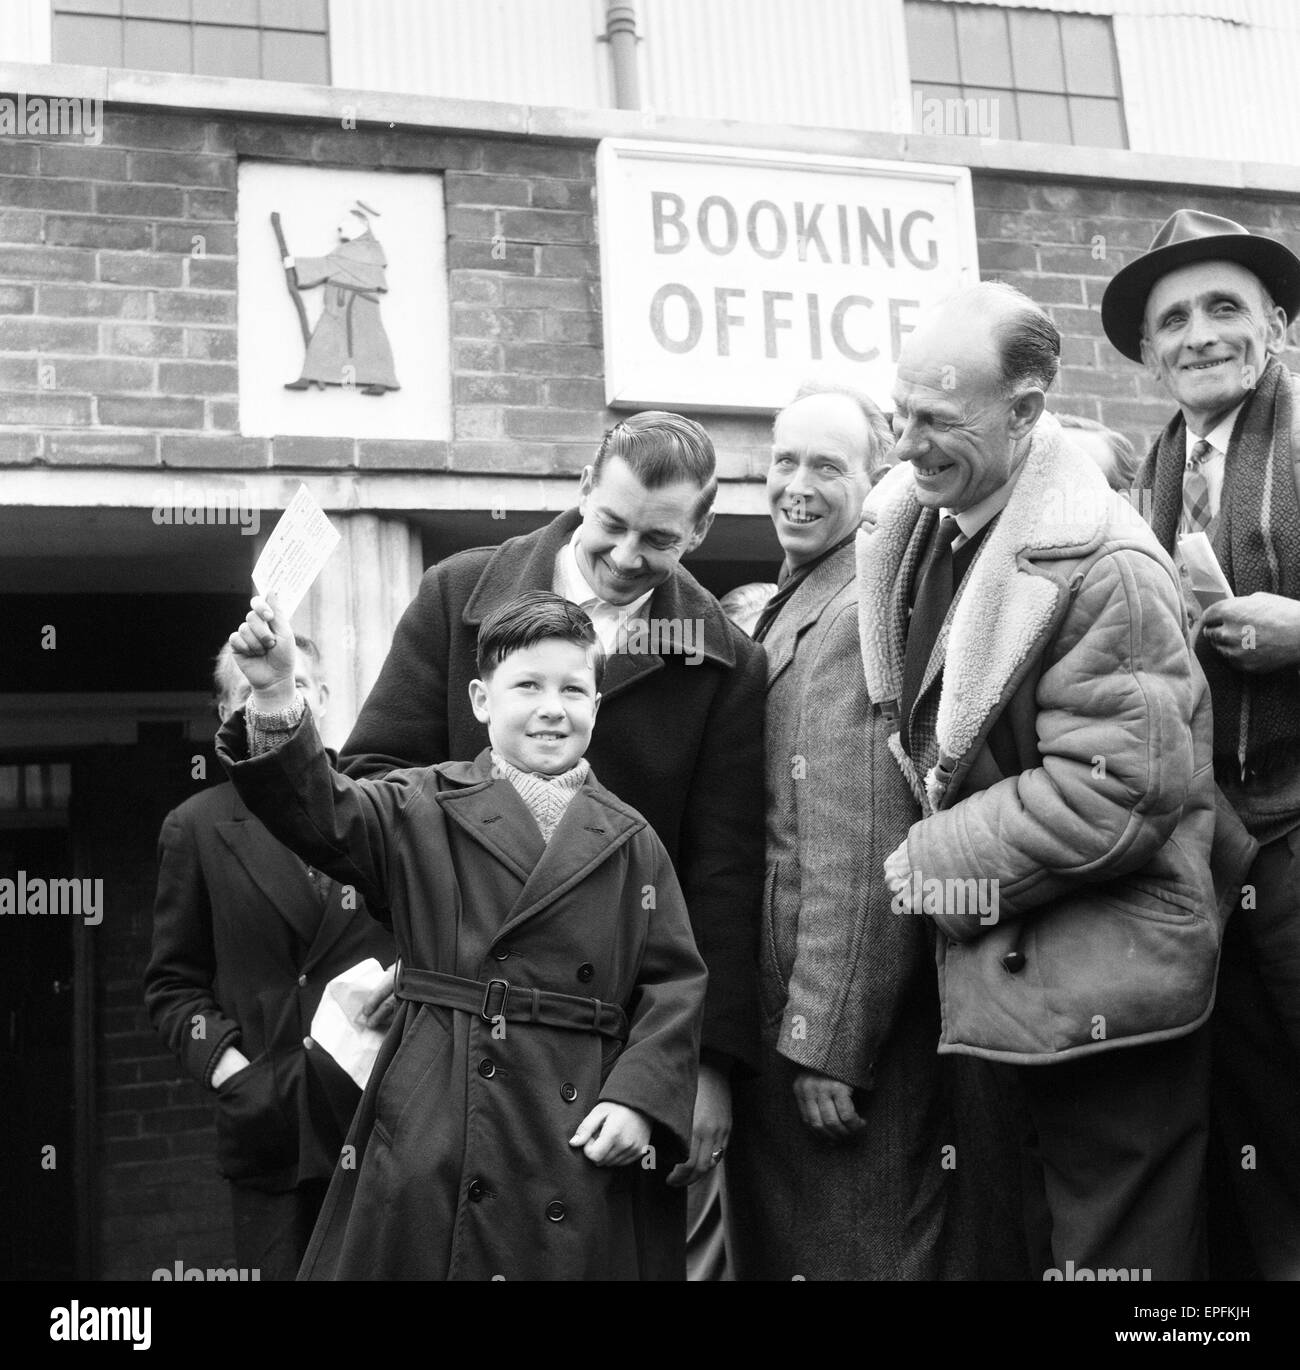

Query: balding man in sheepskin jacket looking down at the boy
left=859, top=284, right=1249, bottom=1280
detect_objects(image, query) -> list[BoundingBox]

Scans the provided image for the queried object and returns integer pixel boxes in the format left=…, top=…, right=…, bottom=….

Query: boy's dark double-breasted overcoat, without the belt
left=218, top=714, right=705, bottom=1280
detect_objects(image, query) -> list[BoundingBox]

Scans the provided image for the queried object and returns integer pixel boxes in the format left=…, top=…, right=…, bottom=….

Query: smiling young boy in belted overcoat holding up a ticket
left=218, top=592, right=705, bottom=1280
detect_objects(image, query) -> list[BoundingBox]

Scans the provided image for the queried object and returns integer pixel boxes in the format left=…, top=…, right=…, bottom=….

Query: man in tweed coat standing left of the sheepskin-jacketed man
left=726, top=386, right=969, bottom=1280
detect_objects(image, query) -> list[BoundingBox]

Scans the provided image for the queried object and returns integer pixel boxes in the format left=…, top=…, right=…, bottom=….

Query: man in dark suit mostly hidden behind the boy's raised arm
left=144, top=637, right=393, bottom=1280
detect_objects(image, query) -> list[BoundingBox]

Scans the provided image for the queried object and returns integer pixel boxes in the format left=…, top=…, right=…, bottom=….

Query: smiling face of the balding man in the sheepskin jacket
left=893, top=306, right=1041, bottom=514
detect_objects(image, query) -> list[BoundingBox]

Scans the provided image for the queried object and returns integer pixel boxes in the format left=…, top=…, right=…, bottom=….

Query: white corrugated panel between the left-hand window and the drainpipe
left=330, top=0, right=610, bottom=108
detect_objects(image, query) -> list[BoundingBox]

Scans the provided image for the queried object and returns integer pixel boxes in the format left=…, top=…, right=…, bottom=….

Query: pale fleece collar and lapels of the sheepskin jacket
left=858, top=414, right=1138, bottom=807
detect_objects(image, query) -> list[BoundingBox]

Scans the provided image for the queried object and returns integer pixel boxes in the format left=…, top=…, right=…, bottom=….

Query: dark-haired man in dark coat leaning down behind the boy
left=341, top=411, right=764, bottom=1243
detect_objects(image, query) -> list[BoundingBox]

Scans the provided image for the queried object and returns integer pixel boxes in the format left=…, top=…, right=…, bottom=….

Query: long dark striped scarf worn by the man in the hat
left=1136, top=358, right=1300, bottom=782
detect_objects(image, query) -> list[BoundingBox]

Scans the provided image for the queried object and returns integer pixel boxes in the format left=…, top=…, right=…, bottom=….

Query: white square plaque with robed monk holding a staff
left=236, top=160, right=451, bottom=443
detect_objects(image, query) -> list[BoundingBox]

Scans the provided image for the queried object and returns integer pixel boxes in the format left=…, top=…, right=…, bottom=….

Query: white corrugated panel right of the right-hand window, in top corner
left=1115, top=8, right=1300, bottom=163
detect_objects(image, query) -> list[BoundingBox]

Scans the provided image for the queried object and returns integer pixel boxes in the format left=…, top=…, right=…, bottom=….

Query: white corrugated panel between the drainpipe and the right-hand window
left=637, top=0, right=910, bottom=129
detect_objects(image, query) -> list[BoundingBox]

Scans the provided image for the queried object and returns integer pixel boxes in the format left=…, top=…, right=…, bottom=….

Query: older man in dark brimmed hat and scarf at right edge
left=1101, top=210, right=1300, bottom=1280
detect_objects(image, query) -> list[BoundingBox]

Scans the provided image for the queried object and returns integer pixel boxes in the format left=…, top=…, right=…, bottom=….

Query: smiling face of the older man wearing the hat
left=1142, top=262, right=1286, bottom=436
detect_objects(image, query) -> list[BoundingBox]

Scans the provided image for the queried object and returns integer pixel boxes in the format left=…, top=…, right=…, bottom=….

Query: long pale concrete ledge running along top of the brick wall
left=0, top=62, right=1300, bottom=195
